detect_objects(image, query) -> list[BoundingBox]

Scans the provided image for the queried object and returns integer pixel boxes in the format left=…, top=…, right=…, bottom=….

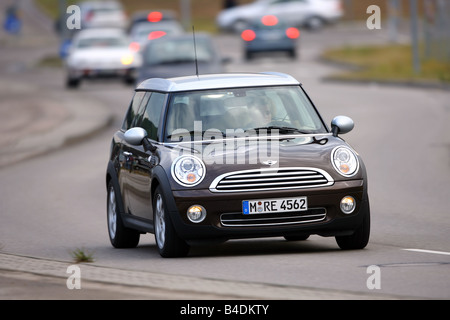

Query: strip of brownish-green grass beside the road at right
left=322, top=45, right=450, bottom=83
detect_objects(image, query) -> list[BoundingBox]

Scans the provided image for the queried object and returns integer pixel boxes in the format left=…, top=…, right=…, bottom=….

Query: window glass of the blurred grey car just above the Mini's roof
left=143, top=37, right=213, bottom=65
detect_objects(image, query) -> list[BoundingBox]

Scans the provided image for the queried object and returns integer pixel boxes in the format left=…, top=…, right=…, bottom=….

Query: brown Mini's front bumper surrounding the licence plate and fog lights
left=170, top=180, right=368, bottom=240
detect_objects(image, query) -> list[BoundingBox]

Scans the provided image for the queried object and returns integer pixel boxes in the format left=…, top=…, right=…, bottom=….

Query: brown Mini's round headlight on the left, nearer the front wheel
left=171, top=156, right=206, bottom=187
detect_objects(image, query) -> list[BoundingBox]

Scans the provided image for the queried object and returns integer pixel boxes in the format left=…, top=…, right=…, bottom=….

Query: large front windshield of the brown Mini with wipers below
left=165, top=86, right=327, bottom=142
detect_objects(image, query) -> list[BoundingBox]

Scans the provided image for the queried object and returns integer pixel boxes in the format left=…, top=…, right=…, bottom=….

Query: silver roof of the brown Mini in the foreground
left=136, top=72, right=300, bottom=92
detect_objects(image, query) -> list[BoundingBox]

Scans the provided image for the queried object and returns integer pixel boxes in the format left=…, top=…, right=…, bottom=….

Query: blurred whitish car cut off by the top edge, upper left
left=79, top=0, right=128, bottom=29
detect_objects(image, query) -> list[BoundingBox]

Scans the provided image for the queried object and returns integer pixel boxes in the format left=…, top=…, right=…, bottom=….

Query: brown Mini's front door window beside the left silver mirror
left=140, top=92, right=166, bottom=141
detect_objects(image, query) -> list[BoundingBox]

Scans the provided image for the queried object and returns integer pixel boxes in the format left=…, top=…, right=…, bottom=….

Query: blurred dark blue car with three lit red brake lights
left=241, top=15, right=300, bottom=60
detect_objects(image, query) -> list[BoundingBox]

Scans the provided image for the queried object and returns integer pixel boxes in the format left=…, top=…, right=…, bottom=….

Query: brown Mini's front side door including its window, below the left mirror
left=127, top=92, right=166, bottom=220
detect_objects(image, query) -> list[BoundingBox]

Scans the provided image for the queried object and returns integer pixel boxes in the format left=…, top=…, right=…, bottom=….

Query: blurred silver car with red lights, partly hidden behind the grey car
left=130, top=20, right=184, bottom=51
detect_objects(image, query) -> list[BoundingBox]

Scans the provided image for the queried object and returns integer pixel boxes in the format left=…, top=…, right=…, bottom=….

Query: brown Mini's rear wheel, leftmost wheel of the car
left=106, top=182, right=140, bottom=248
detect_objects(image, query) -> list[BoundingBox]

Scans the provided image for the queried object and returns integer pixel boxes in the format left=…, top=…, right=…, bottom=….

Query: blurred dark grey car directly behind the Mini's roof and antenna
left=137, top=33, right=227, bottom=83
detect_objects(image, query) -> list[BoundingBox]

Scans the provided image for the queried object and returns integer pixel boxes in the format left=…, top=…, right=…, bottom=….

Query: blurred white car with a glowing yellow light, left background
left=65, top=29, right=142, bottom=88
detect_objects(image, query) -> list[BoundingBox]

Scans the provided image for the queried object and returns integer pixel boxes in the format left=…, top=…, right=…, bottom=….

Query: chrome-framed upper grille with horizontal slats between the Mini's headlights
left=209, top=168, right=334, bottom=192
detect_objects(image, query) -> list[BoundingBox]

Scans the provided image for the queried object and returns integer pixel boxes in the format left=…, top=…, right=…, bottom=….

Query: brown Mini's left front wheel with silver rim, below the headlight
left=153, top=187, right=189, bottom=258
